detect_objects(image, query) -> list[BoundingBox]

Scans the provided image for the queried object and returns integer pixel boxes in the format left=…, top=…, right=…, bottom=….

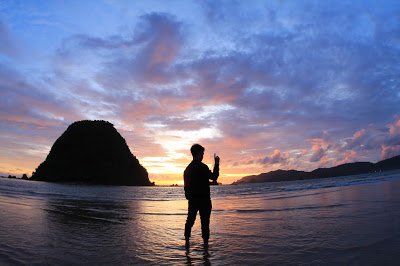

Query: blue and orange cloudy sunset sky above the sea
left=0, top=0, right=400, bottom=184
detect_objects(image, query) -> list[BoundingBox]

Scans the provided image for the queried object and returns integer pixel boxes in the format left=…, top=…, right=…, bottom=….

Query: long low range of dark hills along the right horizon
left=232, top=155, right=400, bottom=185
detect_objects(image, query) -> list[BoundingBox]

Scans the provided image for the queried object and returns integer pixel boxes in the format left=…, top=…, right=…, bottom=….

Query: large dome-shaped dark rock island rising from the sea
left=30, top=120, right=154, bottom=186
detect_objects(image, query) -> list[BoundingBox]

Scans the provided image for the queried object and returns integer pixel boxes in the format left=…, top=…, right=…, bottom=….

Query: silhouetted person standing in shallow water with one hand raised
left=183, top=144, right=219, bottom=248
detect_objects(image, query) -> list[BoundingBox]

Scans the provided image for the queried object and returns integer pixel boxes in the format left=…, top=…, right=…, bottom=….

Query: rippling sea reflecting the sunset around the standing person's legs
left=0, top=171, right=400, bottom=265
